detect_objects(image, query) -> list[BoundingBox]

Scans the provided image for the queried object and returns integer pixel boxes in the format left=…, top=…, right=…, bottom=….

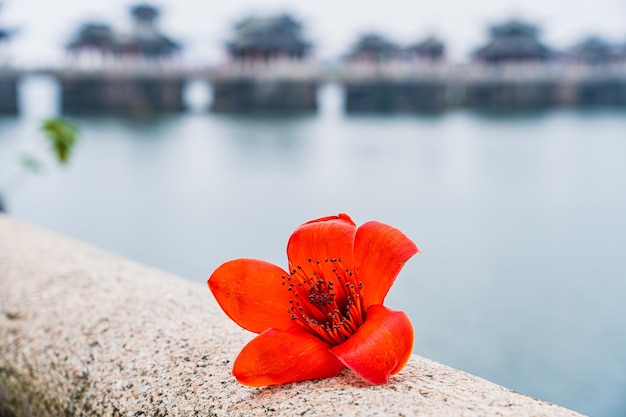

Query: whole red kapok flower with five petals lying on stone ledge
left=208, top=214, right=418, bottom=386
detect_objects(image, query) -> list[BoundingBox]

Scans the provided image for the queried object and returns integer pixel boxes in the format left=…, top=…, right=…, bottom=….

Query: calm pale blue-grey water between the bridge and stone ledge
left=0, top=75, right=626, bottom=417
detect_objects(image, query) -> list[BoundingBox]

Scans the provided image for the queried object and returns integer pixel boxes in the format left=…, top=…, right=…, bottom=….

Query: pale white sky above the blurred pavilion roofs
left=0, top=0, right=626, bottom=67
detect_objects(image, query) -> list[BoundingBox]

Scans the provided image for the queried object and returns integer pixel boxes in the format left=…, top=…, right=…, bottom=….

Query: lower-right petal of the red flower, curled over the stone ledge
left=330, top=305, right=413, bottom=385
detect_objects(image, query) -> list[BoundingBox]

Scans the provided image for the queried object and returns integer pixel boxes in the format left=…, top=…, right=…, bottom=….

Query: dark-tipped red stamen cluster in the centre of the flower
left=283, top=258, right=364, bottom=346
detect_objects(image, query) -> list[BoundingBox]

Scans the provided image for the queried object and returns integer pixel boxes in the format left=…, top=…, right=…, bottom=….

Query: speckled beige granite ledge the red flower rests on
left=0, top=216, right=580, bottom=417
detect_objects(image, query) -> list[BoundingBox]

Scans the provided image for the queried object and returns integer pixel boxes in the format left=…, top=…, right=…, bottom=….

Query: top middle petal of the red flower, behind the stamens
left=287, top=214, right=356, bottom=270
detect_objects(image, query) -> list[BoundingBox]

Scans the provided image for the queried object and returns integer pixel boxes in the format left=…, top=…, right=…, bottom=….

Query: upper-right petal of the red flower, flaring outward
left=354, top=221, right=419, bottom=308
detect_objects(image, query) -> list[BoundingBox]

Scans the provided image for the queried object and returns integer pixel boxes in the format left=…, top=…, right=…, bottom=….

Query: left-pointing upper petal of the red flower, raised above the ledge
left=207, top=259, right=293, bottom=333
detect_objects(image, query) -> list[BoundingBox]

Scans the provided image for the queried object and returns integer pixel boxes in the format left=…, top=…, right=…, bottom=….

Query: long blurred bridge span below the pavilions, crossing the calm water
left=0, top=60, right=626, bottom=113
